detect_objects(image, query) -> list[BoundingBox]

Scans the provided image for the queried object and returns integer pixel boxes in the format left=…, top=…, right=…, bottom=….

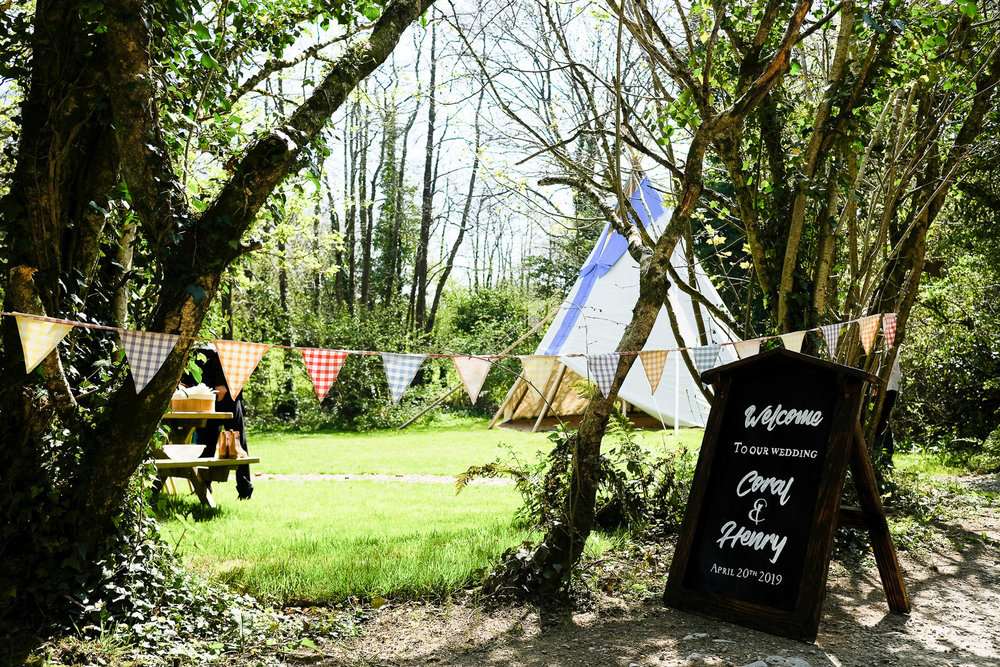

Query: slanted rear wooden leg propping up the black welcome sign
left=851, top=422, right=910, bottom=614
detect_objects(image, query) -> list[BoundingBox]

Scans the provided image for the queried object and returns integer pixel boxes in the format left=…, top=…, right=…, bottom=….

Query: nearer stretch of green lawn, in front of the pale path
left=161, top=478, right=529, bottom=603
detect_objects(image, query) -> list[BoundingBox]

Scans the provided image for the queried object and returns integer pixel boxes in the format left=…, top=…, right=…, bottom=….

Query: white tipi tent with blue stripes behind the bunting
left=494, top=178, right=736, bottom=428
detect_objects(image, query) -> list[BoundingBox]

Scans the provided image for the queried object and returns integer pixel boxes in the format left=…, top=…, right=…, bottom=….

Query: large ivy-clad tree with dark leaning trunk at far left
left=0, top=0, right=433, bottom=620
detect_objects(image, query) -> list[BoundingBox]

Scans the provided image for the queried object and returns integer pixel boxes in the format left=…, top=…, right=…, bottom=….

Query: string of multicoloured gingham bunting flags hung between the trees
left=0, top=311, right=896, bottom=403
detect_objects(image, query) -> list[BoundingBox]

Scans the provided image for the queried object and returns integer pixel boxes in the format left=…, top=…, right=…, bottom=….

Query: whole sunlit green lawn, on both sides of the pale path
left=154, top=422, right=702, bottom=604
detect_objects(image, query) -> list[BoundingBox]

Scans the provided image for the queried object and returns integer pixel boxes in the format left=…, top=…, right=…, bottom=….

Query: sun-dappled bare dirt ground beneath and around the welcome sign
left=302, top=475, right=1000, bottom=667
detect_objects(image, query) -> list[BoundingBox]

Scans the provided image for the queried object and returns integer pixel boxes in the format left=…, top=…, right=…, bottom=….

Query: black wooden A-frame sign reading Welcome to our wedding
left=663, top=350, right=910, bottom=641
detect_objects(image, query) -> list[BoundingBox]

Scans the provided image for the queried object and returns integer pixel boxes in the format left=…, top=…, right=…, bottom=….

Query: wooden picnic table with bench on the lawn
left=153, top=412, right=260, bottom=508
